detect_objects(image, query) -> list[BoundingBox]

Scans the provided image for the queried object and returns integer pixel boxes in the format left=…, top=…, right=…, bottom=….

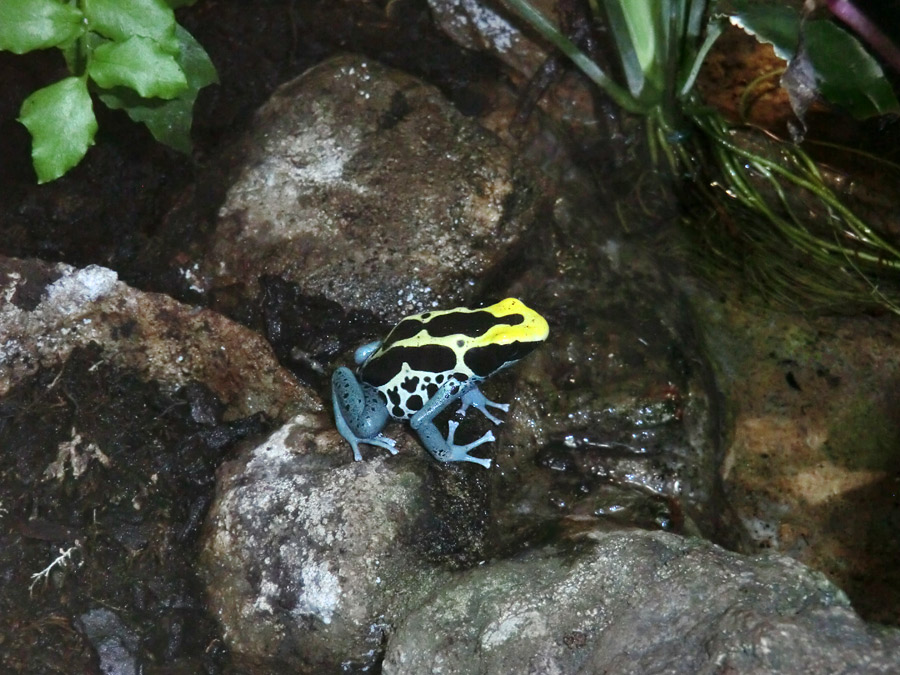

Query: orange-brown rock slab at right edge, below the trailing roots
left=705, top=303, right=900, bottom=625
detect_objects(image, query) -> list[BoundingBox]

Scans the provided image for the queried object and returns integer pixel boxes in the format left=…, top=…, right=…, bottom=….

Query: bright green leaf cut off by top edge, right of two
left=84, top=0, right=178, bottom=55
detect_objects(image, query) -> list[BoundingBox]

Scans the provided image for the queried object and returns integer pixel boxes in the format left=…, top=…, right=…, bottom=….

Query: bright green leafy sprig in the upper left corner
left=0, top=0, right=217, bottom=183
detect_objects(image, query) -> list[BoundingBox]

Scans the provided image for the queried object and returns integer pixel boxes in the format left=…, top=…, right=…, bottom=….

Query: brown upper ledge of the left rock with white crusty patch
left=0, top=257, right=319, bottom=419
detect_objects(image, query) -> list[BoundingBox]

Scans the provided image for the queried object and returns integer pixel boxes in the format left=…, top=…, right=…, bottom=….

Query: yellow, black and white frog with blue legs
left=331, top=298, right=549, bottom=468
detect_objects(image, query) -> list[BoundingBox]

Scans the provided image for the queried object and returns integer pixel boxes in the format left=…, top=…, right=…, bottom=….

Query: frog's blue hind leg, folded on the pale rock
left=331, top=367, right=397, bottom=462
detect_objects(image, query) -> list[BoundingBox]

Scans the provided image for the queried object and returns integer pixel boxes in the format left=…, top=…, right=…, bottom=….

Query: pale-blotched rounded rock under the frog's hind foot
left=201, top=415, right=480, bottom=672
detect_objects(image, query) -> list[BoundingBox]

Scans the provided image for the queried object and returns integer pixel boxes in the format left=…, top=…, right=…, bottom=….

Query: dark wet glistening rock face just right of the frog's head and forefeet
left=478, top=194, right=740, bottom=556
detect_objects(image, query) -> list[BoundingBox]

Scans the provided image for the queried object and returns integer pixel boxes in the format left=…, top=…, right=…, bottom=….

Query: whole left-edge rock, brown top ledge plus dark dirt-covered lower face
left=0, top=259, right=317, bottom=673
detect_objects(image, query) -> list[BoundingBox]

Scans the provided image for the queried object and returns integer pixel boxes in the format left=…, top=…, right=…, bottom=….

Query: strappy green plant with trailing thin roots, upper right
left=505, top=0, right=900, bottom=313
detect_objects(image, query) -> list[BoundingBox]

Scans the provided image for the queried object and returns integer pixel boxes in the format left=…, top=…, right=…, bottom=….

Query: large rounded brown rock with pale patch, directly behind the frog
left=203, top=55, right=533, bottom=321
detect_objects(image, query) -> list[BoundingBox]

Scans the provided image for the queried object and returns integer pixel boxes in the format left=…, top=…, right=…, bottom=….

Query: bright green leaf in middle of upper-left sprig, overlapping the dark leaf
left=88, top=35, right=188, bottom=98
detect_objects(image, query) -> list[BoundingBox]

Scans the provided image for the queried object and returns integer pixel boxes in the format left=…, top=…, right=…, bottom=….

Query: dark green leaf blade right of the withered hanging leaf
left=803, top=20, right=900, bottom=119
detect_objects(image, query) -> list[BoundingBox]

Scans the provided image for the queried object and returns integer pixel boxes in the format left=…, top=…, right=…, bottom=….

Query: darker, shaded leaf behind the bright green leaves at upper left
left=100, top=26, right=219, bottom=153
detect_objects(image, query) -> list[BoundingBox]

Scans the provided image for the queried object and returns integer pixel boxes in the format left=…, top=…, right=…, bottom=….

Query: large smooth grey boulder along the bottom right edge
left=383, top=532, right=900, bottom=675
